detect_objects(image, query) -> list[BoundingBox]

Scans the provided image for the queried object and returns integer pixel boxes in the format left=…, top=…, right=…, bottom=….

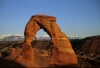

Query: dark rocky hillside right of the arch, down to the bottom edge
left=71, top=36, right=100, bottom=68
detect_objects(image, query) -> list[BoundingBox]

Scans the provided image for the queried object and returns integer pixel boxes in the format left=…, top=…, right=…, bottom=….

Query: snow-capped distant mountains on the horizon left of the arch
left=0, top=34, right=24, bottom=41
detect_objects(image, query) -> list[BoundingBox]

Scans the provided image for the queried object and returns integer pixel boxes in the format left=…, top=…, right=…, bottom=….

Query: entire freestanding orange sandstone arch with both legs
left=16, top=15, right=77, bottom=65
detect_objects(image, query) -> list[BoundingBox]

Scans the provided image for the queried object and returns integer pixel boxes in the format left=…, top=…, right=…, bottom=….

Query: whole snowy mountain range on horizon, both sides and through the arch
left=0, top=34, right=81, bottom=41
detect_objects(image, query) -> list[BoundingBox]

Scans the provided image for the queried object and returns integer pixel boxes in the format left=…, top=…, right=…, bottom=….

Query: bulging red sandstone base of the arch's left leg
left=15, top=44, right=34, bottom=67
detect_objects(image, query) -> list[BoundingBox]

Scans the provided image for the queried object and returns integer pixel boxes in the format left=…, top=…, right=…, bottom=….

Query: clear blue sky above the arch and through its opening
left=0, top=0, right=100, bottom=37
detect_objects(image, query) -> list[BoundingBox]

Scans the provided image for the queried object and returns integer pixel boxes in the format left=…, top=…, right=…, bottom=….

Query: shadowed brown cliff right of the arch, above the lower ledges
left=71, top=36, right=100, bottom=57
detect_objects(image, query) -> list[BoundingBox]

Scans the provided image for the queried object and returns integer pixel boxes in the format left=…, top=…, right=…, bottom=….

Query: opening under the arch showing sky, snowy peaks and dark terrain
left=31, top=29, right=52, bottom=51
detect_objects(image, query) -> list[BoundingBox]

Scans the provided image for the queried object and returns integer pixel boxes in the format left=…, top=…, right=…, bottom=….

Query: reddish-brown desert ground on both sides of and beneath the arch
left=0, top=36, right=100, bottom=68
